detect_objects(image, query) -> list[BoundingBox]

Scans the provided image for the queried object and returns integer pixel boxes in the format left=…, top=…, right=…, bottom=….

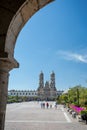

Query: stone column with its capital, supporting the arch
left=0, top=59, right=17, bottom=130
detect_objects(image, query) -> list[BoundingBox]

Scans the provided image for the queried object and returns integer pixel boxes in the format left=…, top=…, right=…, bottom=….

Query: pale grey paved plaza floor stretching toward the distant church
left=5, top=102, right=87, bottom=130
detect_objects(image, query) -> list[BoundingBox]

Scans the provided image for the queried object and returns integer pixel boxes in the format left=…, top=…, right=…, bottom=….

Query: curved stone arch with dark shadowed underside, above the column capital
left=0, top=0, right=53, bottom=68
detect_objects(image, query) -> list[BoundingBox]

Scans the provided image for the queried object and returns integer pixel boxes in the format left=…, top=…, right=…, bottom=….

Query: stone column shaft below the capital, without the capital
left=0, top=68, right=9, bottom=130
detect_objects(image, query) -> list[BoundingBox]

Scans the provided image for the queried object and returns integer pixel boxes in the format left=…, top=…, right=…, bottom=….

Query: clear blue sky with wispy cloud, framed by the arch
left=9, top=0, right=87, bottom=90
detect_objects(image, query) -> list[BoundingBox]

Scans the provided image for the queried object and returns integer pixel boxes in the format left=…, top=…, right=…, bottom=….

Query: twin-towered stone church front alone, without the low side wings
left=37, top=72, right=57, bottom=100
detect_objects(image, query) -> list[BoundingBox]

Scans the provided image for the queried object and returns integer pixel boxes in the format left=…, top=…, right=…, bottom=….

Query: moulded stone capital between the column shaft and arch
left=0, top=58, right=19, bottom=72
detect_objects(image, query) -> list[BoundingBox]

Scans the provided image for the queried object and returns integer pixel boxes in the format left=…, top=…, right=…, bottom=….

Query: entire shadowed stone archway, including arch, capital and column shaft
left=0, top=0, right=53, bottom=130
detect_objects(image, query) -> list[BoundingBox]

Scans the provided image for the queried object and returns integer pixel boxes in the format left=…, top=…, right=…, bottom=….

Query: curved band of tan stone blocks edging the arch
left=5, top=0, right=54, bottom=58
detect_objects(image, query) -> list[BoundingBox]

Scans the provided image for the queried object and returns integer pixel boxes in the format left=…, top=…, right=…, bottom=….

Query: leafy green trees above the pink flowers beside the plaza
left=59, top=85, right=87, bottom=106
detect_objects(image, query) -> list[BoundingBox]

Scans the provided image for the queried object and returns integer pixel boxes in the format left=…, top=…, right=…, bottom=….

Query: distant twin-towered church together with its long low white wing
left=8, top=72, right=64, bottom=100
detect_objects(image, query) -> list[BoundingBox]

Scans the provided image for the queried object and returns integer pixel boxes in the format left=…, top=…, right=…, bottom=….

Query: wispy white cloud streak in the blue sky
left=57, top=51, right=87, bottom=63
